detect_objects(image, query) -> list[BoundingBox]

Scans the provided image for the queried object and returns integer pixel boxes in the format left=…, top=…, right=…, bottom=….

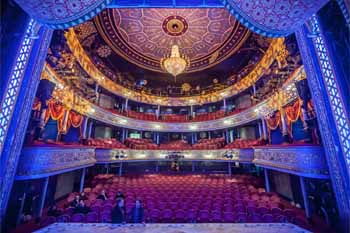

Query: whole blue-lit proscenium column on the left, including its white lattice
left=0, top=19, right=52, bottom=221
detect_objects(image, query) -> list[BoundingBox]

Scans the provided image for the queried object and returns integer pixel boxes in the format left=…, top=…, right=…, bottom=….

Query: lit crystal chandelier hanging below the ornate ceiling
left=160, top=45, right=190, bottom=78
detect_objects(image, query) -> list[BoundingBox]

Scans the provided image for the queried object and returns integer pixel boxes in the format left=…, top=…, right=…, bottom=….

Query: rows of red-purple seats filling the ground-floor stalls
left=40, top=174, right=310, bottom=228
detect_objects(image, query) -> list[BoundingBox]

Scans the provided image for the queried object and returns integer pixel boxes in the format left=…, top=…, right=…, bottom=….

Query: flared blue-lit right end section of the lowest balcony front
left=253, top=145, right=328, bottom=178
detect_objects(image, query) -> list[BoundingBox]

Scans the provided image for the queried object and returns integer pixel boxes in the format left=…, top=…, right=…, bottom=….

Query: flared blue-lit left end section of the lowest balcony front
left=16, top=146, right=96, bottom=180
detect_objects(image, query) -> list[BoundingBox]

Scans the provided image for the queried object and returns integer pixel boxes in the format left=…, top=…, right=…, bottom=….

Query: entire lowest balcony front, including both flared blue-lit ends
left=16, top=145, right=328, bottom=180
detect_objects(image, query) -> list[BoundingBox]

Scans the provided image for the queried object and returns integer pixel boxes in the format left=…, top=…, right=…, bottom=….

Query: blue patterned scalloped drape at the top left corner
left=15, top=0, right=112, bottom=29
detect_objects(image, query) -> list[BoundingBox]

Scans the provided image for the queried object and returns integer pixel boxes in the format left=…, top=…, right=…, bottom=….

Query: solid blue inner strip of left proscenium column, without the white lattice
left=0, top=24, right=53, bottom=221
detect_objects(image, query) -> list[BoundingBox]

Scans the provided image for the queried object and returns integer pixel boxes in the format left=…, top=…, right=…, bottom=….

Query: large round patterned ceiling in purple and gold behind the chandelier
left=94, top=8, right=250, bottom=73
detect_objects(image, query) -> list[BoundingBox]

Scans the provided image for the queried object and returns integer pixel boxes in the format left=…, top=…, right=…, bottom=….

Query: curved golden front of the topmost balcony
left=65, top=28, right=288, bottom=106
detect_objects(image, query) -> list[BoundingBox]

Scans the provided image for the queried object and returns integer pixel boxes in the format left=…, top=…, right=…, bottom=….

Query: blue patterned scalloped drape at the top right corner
left=222, top=0, right=328, bottom=37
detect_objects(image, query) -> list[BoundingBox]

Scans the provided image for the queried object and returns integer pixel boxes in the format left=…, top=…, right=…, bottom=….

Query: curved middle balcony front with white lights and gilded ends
left=42, top=65, right=305, bottom=132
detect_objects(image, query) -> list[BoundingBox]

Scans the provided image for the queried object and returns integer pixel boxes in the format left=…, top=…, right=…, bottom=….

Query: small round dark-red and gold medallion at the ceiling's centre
left=162, top=15, right=188, bottom=36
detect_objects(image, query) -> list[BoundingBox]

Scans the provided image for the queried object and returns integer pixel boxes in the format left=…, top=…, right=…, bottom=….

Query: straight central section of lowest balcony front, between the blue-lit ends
left=96, top=149, right=254, bottom=163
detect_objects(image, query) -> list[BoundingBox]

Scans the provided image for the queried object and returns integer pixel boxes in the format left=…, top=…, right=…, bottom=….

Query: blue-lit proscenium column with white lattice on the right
left=296, top=15, right=350, bottom=232
